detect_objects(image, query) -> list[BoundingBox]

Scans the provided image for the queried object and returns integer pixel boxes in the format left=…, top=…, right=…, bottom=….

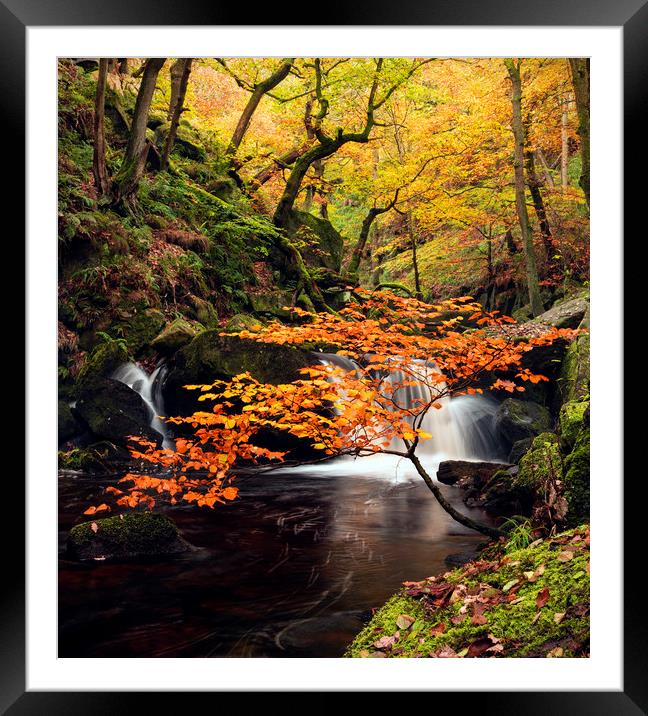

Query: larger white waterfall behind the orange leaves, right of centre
left=306, top=353, right=504, bottom=476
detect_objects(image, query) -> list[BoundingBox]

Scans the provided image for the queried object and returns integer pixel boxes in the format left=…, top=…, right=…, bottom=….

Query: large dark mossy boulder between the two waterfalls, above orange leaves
left=163, top=330, right=315, bottom=415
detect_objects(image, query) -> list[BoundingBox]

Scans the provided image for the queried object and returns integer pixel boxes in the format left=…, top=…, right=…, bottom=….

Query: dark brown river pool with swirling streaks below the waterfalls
left=58, top=458, right=494, bottom=657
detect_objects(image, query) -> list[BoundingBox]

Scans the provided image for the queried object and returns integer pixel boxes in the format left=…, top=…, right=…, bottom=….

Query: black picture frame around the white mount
left=0, top=0, right=632, bottom=716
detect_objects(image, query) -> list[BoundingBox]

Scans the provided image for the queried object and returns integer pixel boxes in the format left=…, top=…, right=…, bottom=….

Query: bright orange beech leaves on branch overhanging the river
left=86, top=289, right=577, bottom=514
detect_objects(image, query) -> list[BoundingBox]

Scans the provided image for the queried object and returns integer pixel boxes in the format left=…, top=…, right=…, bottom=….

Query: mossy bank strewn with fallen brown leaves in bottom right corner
left=345, top=526, right=590, bottom=658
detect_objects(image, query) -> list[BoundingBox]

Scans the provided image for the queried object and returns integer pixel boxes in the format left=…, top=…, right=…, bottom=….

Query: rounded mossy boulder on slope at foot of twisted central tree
left=286, top=210, right=344, bottom=272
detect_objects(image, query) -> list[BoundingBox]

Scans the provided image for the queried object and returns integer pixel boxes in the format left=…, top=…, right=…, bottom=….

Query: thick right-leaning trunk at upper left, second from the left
left=113, top=57, right=166, bottom=205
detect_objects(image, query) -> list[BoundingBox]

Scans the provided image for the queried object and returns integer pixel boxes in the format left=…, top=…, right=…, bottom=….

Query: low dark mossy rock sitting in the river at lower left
left=66, top=512, right=193, bottom=561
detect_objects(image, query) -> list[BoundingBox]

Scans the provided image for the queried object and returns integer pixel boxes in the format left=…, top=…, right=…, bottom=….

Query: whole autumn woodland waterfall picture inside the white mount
left=58, top=57, right=590, bottom=659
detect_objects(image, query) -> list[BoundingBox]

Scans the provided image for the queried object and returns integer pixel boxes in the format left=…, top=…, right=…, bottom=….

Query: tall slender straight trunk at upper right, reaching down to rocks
left=504, top=59, right=544, bottom=316
